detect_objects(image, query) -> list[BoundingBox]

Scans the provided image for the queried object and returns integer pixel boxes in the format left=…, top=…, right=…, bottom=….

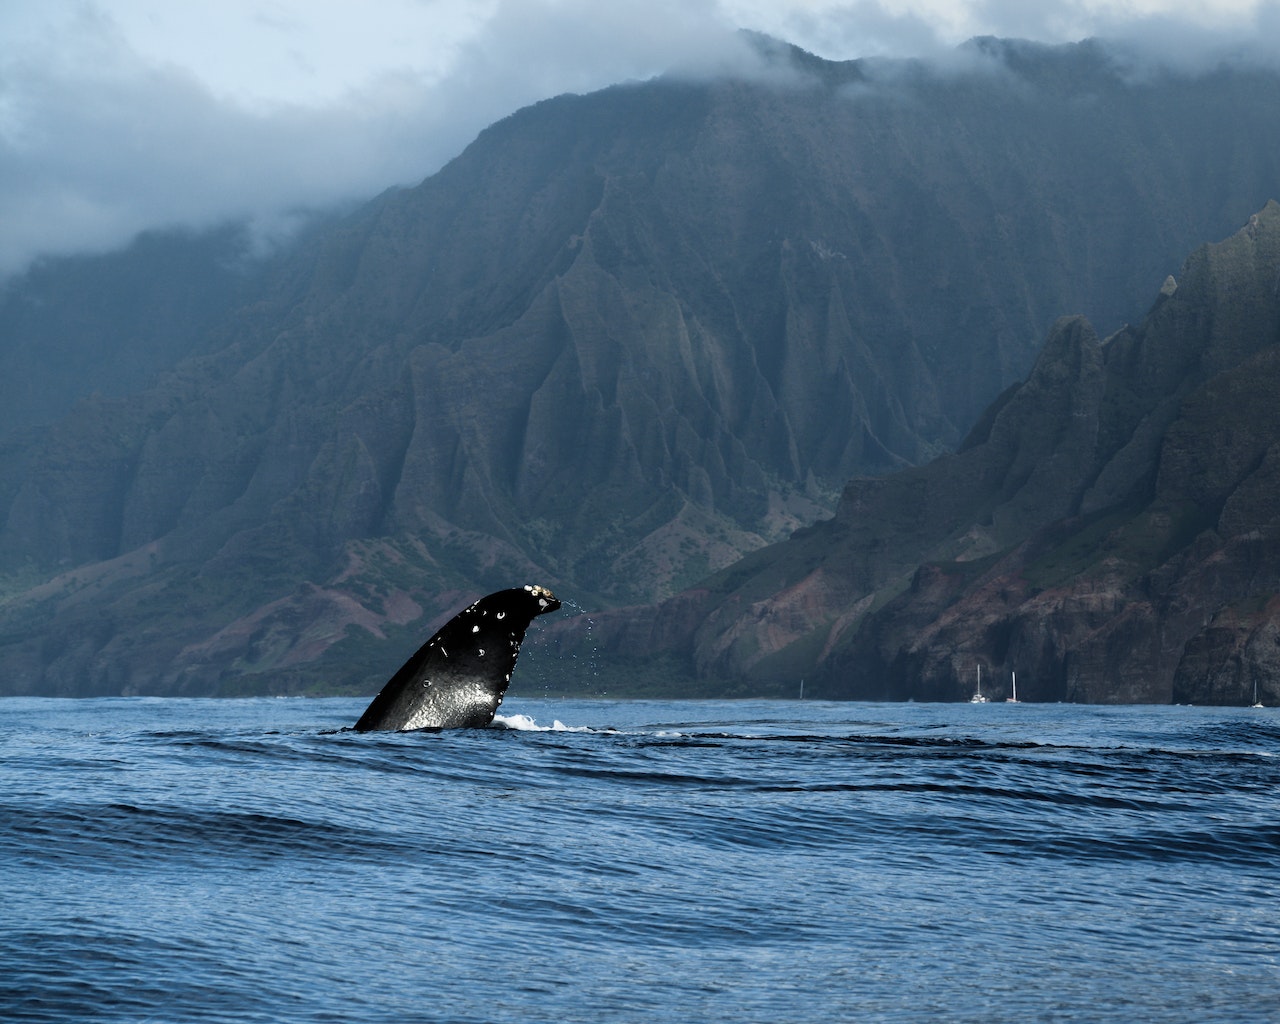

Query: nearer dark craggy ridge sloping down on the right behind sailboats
left=568, top=202, right=1280, bottom=704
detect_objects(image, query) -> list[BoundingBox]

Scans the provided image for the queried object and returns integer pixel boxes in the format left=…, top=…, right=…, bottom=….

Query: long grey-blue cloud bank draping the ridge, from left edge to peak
left=0, top=0, right=746, bottom=274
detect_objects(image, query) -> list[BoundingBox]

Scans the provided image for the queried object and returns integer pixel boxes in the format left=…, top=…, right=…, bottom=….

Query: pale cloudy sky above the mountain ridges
left=0, top=0, right=1280, bottom=278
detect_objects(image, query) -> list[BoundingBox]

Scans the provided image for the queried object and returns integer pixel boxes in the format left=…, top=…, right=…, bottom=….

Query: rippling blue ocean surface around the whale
left=0, top=698, right=1280, bottom=1024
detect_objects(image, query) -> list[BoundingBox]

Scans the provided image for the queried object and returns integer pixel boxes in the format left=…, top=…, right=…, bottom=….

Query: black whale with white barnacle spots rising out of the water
left=353, top=585, right=561, bottom=732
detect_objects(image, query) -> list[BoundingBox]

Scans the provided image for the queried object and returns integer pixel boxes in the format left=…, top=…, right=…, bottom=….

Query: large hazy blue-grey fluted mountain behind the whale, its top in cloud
left=0, top=40, right=1280, bottom=694
